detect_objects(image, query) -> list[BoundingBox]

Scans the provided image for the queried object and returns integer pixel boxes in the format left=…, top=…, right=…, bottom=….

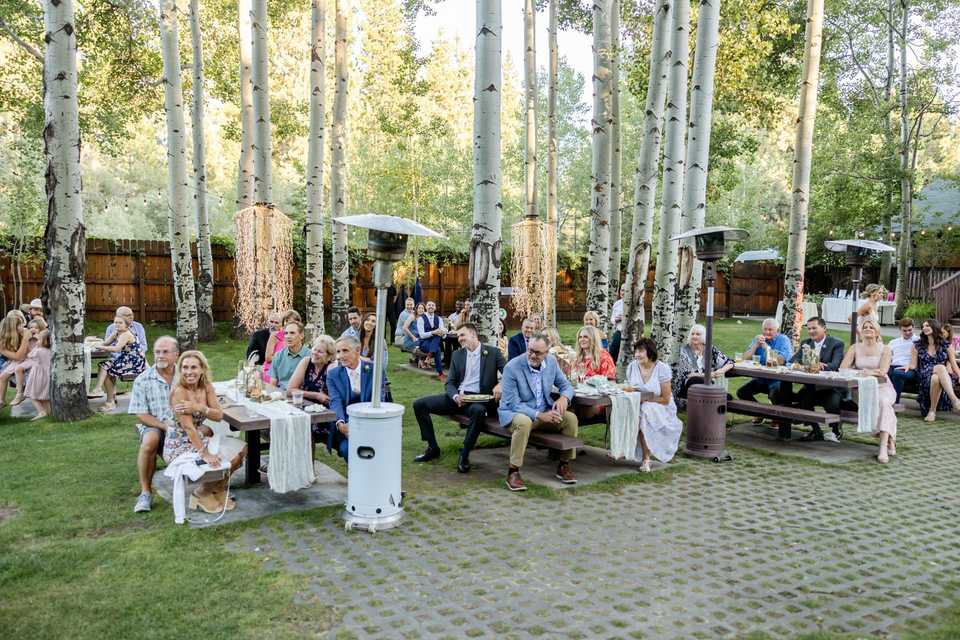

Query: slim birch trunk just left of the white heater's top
left=330, top=0, right=350, bottom=335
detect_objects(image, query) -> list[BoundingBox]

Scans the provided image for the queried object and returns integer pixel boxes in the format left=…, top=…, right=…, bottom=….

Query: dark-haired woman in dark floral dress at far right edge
left=908, top=318, right=960, bottom=422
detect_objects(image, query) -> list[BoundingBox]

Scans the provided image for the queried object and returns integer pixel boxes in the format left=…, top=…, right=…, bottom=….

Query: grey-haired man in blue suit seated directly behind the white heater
left=325, top=336, right=387, bottom=460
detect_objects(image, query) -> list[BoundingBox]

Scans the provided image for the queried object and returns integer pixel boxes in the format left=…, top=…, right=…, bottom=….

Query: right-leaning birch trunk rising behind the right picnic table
left=780, top=0, right=823, bottom=347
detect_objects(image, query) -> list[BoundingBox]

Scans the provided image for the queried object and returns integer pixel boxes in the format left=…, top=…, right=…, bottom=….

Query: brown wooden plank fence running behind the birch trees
left=0, top=239, right=908, bottom=326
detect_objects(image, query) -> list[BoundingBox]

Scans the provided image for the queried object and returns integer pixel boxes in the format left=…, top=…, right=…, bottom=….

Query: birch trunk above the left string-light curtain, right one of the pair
left=251, top=0, right=273, bottom=204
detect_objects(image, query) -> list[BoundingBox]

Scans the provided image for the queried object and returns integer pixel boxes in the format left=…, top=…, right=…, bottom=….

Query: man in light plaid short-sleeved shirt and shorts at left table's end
left=127, top=336, right=180, bottom=513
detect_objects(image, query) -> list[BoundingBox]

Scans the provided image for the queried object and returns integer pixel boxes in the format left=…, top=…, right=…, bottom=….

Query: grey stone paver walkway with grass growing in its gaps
left=229, top=419, right=960, bottom=639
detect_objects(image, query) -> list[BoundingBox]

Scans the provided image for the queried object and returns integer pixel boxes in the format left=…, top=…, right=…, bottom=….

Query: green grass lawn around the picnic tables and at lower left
left=0, top=321, right=957, bottom=639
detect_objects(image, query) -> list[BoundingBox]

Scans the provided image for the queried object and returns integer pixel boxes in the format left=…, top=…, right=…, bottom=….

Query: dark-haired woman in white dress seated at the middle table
left=627, top=338, right=683, bottom=472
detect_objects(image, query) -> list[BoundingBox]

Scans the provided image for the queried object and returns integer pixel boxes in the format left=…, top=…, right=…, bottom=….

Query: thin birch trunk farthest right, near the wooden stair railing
left=895, top=0, right=913, bottom=318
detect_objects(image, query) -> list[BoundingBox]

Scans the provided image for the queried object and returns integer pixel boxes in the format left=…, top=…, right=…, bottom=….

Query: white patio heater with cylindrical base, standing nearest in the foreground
left=334, top=213, right=443, bottom=533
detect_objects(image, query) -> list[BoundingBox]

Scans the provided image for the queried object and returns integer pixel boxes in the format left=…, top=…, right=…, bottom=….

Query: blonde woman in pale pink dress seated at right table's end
left=840, top=318, right=900, bottom=464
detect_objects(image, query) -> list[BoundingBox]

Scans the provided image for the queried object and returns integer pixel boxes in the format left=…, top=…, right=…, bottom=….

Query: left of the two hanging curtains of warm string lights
left=234, top=203, right=293, bottom=331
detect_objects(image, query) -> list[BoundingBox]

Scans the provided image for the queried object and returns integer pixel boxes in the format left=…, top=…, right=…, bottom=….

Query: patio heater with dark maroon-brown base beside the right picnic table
left=670, top=227, right=748, bottom=462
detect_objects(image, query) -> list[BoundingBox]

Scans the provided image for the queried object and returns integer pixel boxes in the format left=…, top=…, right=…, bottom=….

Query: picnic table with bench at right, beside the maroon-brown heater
left=727, top=363, right=859, bottom=440
